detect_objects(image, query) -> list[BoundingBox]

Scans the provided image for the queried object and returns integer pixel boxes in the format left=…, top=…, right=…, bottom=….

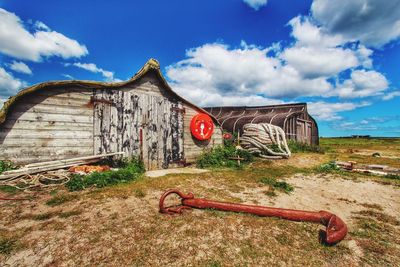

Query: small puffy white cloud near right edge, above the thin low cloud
left=331, top=70, right=389, bottom=98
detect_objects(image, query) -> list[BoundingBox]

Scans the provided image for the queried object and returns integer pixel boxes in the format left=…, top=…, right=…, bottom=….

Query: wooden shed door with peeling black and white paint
left=94, top=90, right=184, bottom=170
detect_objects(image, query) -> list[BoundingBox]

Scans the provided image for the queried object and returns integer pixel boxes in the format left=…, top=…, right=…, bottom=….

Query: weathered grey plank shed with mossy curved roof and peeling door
left=0, top=59, right=223, bottom=169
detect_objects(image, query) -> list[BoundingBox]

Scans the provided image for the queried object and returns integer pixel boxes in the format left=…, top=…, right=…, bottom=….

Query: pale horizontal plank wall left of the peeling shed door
left=0, top=88, right=93, bottom=164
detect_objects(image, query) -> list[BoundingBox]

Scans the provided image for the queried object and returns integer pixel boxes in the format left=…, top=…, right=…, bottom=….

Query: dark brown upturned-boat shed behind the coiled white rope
left=204, top=103, right=319, bottom=145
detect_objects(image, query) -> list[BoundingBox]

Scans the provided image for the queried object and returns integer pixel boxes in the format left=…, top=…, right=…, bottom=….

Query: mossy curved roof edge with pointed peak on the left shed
left=0, top=58, right=218, bottom=124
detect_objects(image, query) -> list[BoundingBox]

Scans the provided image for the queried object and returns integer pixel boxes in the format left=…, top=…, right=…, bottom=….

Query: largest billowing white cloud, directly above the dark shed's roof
left=166, top=44, right=331, bottom=103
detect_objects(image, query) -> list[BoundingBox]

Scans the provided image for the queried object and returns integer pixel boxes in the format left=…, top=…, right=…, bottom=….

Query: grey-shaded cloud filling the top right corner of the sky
left=311, top=0, right=400, bottom=48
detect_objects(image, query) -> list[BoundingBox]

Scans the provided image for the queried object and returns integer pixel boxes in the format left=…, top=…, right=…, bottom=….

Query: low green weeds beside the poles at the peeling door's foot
left=66, top=159, right=145, bottom=191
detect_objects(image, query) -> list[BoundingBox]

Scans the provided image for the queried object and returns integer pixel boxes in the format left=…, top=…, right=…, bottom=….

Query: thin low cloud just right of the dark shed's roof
left=308, top=101, right=371, bottom=121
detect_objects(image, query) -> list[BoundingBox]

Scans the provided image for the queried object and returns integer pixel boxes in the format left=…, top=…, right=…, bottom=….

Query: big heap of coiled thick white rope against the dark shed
left=240, top=123, right=291, bottom=158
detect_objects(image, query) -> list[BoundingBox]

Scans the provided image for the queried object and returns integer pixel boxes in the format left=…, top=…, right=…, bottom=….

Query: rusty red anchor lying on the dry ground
left=159, top=189, right=347, bottom=245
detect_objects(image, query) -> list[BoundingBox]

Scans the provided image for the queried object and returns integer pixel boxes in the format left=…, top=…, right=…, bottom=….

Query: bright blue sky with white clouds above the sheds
left=0, top=0, right=400, bottom=136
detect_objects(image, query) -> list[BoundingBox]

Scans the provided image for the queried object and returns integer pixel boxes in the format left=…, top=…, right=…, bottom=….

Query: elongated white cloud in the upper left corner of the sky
left=0, top=8, right=88, bottom=61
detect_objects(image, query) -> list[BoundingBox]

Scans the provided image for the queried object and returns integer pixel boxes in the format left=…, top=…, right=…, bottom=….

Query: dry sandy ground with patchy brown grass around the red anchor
left=0, top=139, right=400, bottom=266
